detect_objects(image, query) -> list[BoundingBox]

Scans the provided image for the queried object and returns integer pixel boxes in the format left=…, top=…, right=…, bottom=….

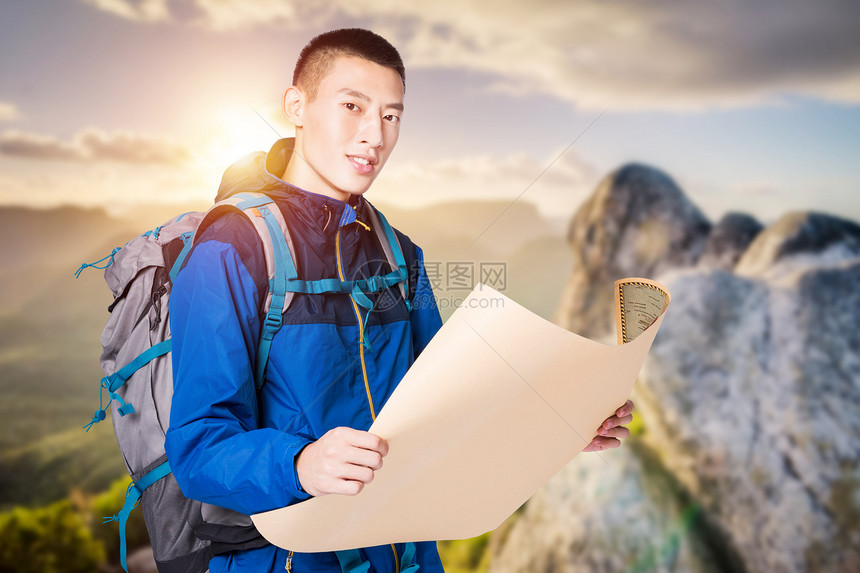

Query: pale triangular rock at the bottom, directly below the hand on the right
left=490, top=439, right=737, bottom=573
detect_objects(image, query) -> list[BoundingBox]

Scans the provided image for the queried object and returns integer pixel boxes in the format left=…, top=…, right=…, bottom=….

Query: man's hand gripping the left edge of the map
left=296, top=427, right=388, bottom=496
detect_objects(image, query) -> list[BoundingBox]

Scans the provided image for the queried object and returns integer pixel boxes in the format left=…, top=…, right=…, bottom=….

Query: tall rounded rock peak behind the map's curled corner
left=556, top=165, right=711, bottom=337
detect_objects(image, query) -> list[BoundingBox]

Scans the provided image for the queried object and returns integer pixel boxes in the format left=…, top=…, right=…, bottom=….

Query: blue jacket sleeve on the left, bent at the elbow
left=165, top=232, right=309, bottom=514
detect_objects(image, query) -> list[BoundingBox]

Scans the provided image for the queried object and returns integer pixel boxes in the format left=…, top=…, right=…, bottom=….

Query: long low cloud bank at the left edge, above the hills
left=0, top=128, right=191, bottom=164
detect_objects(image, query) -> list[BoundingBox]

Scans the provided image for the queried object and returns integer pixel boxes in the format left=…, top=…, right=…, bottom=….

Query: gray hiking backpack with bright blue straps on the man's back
left=81, top=193, right=409, bottom=573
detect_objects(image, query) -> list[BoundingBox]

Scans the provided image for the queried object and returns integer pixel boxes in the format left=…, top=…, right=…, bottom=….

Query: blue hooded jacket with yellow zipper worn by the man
left=165, top=140, right=442, bottom=573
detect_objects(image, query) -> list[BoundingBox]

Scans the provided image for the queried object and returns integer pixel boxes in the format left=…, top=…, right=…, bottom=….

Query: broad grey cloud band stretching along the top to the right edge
left=75, top=0, right=860, bottom=110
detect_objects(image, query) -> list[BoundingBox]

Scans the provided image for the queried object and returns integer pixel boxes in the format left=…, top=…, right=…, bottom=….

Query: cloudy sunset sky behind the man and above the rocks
left=0, top=0, right=860, bottom=228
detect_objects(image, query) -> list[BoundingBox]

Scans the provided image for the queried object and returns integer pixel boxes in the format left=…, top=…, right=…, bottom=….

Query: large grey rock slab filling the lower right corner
left=639, top=261, right=860, bottom=571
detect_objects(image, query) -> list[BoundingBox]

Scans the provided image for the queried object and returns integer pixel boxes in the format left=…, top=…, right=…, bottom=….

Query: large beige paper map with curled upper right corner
left=252, top=278, right=669, bottom=552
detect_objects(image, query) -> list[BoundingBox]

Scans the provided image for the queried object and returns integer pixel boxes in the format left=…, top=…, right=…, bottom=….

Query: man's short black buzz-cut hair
left=293, top=28, right=406, bottom=99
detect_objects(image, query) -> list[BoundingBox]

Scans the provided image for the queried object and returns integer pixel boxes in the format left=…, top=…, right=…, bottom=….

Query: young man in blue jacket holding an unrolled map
left=165, top=29, right=633, bottom=573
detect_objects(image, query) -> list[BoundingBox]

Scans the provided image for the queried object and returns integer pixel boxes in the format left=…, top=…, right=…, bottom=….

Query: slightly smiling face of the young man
left=287, top=56, right=403, bottom=201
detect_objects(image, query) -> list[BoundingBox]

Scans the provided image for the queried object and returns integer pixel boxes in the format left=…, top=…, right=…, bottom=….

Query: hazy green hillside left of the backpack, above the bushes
left=0, top=208, right=136, bottom=506
